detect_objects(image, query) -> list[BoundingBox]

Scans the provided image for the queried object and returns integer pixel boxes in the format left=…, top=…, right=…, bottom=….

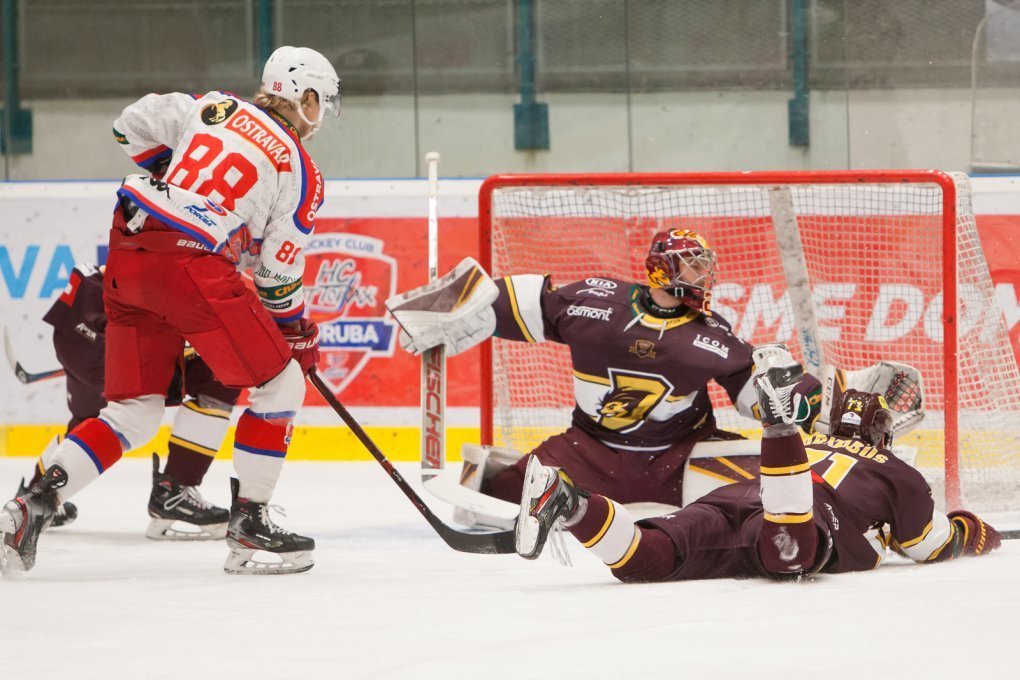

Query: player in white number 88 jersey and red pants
left=0, top=47, right=340, bottom=574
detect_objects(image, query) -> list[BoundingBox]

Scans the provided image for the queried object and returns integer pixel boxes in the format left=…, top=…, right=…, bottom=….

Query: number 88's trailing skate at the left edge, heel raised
left=0, top=465, right=67, bottom=575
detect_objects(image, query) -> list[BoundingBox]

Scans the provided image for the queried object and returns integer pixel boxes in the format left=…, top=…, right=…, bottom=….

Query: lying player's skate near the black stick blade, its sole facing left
left=514, top=456, right=580, bottom=560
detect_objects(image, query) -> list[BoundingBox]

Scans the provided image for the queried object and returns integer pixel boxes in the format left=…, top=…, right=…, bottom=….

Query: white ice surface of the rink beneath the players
left=0, top=458, right=1020, bottom=680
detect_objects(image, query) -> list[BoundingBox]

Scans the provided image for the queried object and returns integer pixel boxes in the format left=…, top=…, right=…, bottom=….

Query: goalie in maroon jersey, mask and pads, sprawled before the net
left=387, top=229, right=934, bottom=528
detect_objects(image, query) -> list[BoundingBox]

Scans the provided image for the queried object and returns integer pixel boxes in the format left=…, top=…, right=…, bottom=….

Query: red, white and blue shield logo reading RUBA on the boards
left=304, top=233, right=397, bottom=394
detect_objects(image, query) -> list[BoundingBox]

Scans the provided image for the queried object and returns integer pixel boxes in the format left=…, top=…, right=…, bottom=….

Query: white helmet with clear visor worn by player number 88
left=262, top=46, right=340, bottom=128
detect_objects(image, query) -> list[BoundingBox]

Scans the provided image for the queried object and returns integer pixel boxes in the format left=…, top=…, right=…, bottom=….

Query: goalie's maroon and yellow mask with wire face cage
left=645, top=229, right=715, bottom=312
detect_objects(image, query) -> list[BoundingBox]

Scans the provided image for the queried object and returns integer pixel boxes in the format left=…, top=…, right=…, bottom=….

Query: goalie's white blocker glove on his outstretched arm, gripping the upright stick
left=386, top=257, right=499, bottom=356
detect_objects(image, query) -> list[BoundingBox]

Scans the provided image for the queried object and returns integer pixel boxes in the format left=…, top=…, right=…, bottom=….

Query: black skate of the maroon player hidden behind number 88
left=145, top=454, right=231, bottom=540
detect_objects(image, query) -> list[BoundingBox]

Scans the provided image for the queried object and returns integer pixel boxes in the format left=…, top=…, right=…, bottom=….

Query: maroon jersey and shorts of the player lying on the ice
left=640, top=434, right=952, bottom=580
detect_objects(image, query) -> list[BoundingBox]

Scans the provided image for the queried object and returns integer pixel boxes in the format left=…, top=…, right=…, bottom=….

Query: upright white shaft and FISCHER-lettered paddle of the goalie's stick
left=421, top=151, right=446, bottom=481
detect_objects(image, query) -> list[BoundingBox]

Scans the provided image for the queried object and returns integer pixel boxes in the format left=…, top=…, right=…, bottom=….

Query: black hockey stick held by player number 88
left=308, top=370, right=516, bottom=555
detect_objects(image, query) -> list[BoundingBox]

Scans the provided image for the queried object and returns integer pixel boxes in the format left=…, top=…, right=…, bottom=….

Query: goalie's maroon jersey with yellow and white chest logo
left=494, top=274, right=757, bottom=452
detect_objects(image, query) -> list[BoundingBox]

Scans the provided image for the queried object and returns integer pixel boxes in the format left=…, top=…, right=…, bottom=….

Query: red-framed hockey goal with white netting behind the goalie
left=478, top=171, right=1020, bottom=511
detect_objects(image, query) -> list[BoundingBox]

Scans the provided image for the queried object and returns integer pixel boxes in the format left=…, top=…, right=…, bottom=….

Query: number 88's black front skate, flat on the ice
left=223, top=477, right=315, bottom=574
